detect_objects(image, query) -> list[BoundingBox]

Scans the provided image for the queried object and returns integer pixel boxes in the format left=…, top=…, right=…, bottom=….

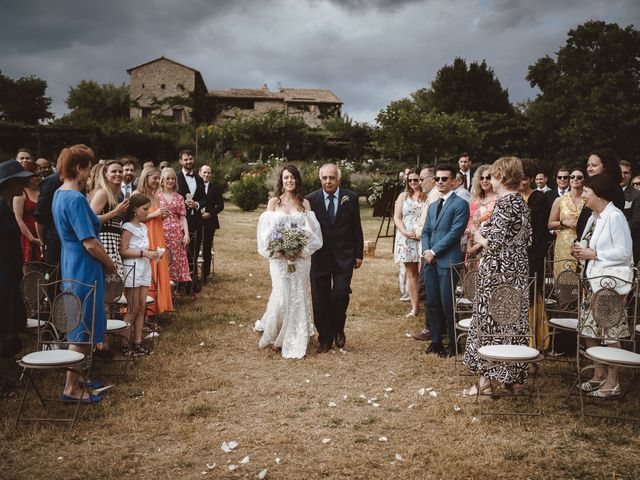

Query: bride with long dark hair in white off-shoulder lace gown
left=256, top=165, right=322, bottom=358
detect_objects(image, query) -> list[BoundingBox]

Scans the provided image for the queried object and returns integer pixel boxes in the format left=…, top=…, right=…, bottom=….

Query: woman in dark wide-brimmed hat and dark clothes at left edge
left=0, top=160, right=33, bottom=396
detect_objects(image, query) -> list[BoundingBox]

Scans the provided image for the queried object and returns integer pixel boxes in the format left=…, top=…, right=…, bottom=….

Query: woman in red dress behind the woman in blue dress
left=13, top=160, right=43, bottom=263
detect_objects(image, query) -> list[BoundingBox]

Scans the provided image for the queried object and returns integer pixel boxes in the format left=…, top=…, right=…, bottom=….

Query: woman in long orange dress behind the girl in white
left=132, top=167, right=173, bottom=315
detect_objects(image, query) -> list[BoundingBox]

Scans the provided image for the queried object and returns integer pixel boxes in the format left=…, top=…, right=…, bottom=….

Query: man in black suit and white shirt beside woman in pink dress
left=176, top=150, right=207, bottom=293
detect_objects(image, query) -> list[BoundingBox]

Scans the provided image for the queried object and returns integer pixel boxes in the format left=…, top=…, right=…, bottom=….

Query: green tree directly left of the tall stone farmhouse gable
left=65, top=80, right=129, bottom=124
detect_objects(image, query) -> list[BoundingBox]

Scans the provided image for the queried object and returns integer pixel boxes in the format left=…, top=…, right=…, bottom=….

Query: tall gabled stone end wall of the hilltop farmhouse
left=130, top=59, right=196, bottom=122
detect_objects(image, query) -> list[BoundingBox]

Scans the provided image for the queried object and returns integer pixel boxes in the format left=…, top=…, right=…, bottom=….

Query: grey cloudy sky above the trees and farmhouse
left=0, top=0, right=640, bottom=122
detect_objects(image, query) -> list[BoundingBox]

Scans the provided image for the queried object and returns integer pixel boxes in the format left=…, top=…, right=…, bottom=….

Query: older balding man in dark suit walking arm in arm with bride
left=307, top=163, right=364, bottom=353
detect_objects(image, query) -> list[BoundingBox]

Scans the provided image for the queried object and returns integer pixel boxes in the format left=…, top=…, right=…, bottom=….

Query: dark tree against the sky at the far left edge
left=0, top=72, right=53, bottom=125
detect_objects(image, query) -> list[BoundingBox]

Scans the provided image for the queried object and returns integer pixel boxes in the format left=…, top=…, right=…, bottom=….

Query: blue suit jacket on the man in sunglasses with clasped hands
left=422, top=193, right=469, bottom=268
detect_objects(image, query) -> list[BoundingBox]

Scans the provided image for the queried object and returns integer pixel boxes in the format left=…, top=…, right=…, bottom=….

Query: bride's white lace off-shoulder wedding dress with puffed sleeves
left=256, top=211, right=322, bottom=358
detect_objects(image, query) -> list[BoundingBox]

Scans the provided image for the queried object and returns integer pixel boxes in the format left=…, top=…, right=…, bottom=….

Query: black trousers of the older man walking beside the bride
left=311, top=270, right=353, bottom=346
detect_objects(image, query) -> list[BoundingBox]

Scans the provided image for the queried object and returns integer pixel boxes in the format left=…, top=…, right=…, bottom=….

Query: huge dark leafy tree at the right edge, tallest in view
left=527, top=21, right=640, bottom=162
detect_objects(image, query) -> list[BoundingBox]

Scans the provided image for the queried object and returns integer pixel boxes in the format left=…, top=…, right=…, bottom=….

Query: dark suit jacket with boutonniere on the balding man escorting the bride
left=307, top=188, right=364, bottom=273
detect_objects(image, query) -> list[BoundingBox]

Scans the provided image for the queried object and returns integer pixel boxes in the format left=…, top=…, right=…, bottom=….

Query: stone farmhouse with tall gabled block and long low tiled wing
left=127, top=57, right=342, bottom=128
